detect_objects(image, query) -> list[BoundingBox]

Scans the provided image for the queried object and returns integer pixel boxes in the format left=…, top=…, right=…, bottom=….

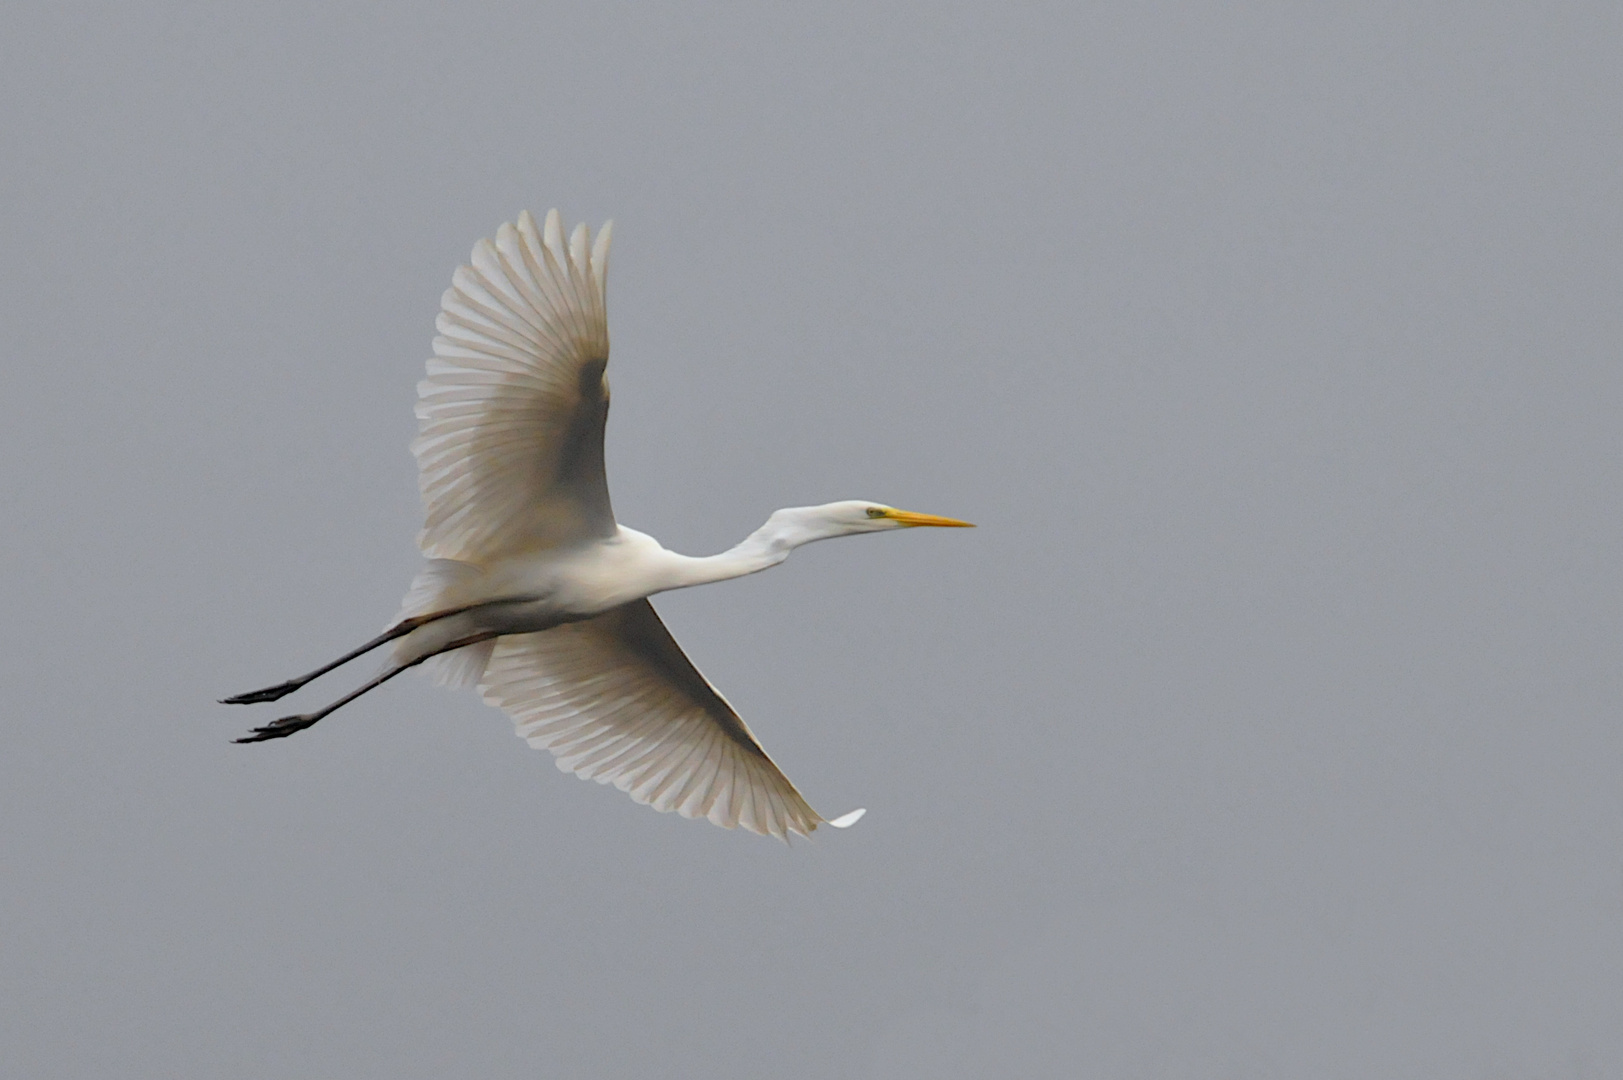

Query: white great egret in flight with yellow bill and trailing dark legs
left=224, top=211, right=969, bottom=840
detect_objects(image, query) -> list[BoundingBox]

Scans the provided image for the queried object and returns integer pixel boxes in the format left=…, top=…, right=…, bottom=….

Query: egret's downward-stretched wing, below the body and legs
left=479, top=599, right=824, bottom=840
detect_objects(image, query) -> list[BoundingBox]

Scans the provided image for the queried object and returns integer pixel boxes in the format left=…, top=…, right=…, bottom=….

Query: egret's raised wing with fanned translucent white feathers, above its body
left=412, top=210, right=615, bottom=564
